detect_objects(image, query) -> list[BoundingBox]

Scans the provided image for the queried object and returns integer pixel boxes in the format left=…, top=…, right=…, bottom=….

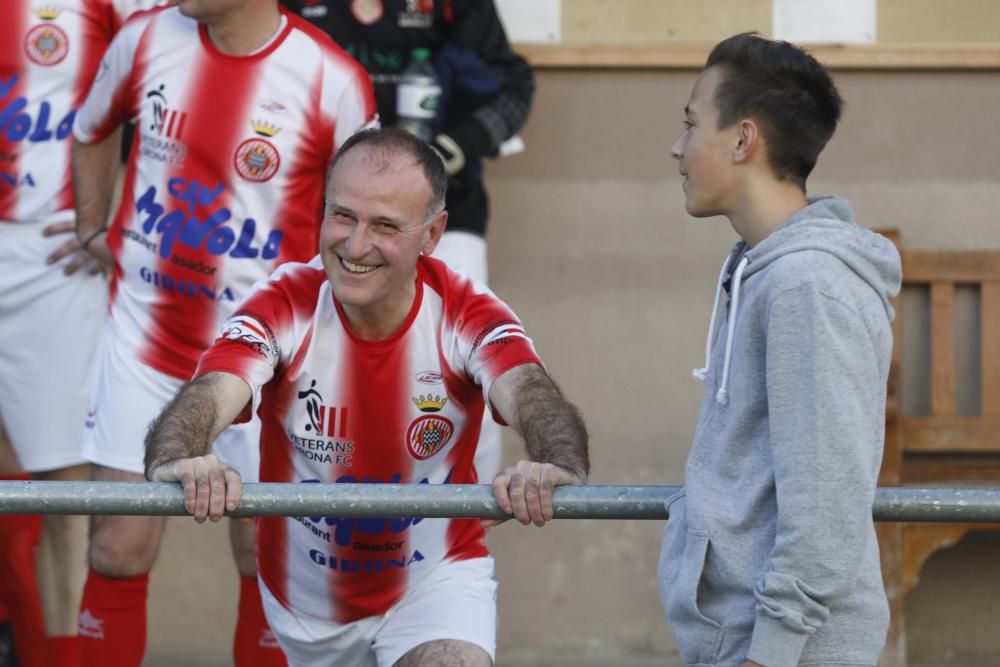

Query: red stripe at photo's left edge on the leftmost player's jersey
left=0, top=2, right=31, bottom=220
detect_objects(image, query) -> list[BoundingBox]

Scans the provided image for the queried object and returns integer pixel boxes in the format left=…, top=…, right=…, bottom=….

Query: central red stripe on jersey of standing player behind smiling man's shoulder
left=141, top=45, right=266, bottom=378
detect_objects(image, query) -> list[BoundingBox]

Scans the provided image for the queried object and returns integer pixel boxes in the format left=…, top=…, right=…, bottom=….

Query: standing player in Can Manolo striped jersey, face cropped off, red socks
left=68, top=0, right=375, bottom=667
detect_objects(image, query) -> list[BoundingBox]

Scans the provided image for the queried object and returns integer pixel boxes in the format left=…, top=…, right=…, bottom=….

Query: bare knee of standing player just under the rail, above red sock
left=87, top=516, right=163, bottom=577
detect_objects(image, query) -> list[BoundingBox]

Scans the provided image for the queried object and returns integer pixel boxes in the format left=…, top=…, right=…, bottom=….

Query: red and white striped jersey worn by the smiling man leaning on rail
left=197, top=257, right=541, bottom=623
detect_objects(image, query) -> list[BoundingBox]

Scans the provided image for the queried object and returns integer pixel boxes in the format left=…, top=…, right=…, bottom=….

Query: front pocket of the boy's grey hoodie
left=661, top=528, right=725, bottom=665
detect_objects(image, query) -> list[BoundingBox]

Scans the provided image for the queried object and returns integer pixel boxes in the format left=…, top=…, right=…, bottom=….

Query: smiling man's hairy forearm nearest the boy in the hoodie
left=517, top=376, right=590, bottom=481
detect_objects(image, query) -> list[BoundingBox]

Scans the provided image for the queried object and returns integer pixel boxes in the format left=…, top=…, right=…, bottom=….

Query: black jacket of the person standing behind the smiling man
left=282, top=0, right=535, bottom=234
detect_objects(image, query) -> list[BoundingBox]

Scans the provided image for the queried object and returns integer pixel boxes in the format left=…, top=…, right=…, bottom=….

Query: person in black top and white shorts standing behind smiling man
left=282, top=0, right=535, bottom=482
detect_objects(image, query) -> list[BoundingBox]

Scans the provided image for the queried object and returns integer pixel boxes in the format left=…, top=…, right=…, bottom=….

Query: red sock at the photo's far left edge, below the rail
left=0, top=475, right=49, bottom=667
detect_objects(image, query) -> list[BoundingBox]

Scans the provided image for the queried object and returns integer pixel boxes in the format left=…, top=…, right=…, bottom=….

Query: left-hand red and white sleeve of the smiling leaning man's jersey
left=195, top=280, right=293, bottom=423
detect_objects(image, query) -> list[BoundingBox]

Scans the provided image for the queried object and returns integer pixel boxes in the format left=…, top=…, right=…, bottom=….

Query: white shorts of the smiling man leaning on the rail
left=258, top=557, right=497, bottom=667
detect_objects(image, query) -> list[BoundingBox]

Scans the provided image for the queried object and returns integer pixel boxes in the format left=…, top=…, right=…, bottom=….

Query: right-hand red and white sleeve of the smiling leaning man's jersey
left=442, top=279, right=542, bottom=414
